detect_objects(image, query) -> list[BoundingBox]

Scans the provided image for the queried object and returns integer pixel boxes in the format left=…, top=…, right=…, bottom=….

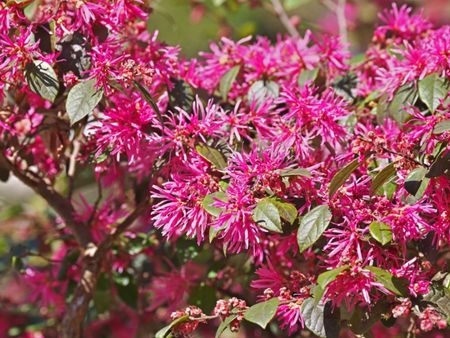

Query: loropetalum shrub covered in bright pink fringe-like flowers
left=0, top=0, right=450, bottom=338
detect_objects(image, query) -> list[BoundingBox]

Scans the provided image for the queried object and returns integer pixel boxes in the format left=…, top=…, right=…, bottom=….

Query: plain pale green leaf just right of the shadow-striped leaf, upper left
left=66, top=79, right=103, bottom=125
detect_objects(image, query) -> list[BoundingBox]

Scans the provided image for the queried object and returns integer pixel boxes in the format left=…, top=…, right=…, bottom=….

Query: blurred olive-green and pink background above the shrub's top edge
left=149, top=0, right=450, bottom=57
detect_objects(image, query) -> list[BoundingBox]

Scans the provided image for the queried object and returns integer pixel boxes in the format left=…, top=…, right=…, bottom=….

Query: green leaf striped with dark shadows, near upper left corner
left=25, top=60, right=59, bottom=102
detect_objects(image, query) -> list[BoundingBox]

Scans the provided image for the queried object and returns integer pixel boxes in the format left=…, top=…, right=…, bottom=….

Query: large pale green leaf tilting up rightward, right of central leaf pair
left=297, top=205, right=332, bottom=252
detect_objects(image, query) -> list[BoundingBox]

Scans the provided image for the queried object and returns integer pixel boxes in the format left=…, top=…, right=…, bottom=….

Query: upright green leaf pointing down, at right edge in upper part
left=419, top=73, right=448, bottom=113
